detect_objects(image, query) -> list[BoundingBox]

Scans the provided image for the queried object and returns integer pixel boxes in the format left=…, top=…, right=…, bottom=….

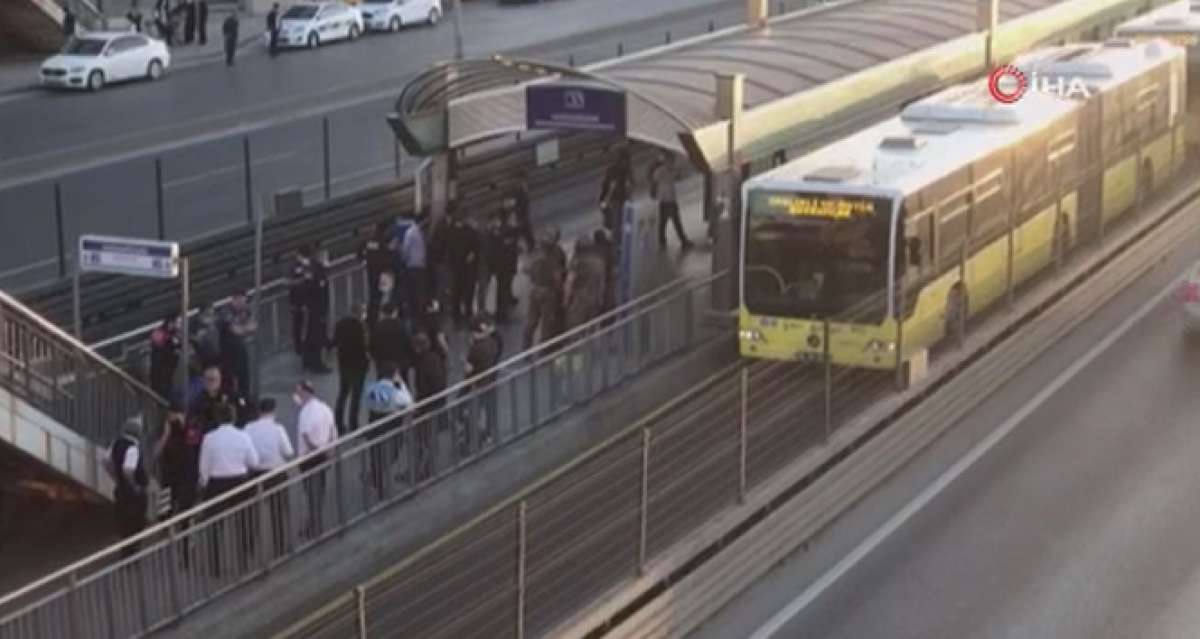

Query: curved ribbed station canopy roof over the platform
left=390, top=0, right=1111, bottom=166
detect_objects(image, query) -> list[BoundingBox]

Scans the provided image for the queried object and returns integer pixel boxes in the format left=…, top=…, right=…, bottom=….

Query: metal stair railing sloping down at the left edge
left=0, top=292, right=166, bottom=446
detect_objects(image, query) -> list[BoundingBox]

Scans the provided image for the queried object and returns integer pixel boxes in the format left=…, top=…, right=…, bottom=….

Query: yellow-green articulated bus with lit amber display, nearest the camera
left=739, top=41, right=1187, bottom=370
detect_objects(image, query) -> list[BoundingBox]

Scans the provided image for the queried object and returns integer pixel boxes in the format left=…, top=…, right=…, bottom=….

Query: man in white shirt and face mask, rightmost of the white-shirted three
left=292, top=381, right=337, bottom=538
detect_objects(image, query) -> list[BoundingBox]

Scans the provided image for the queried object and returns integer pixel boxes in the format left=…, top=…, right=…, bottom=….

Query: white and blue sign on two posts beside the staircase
left=74, top=235, right=187, bottom=381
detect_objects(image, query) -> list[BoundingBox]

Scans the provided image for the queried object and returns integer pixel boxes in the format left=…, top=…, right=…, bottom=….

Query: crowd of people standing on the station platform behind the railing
left=109, top=147, right=690, bottom=562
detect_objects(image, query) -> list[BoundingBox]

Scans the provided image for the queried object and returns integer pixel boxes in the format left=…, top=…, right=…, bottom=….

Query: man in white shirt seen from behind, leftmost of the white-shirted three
left=200, top=404, right=258, bottom=577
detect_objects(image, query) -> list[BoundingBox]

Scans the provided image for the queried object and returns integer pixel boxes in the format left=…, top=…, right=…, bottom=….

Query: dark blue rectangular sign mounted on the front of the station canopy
left=526, top=84, right=626, bottom=136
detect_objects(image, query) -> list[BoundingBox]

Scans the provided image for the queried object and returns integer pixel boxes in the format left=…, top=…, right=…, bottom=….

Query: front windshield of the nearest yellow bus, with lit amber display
left=743, top=190, right=892, bottom=323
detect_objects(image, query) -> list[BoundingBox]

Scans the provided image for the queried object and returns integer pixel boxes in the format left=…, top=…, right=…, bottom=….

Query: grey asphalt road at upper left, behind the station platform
left=0, top=0, right=753, bottom=288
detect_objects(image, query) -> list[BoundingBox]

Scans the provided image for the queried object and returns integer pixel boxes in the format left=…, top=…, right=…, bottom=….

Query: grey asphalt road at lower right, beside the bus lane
left=694, top=221, right=1200, bottom=639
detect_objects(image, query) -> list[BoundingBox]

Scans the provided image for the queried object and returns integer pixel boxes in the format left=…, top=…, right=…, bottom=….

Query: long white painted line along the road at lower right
left=750, top=269, right=1183, bottom=639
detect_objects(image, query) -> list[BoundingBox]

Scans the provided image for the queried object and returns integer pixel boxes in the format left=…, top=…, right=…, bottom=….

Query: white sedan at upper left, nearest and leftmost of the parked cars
left=38, top=31, right=170, bottom=91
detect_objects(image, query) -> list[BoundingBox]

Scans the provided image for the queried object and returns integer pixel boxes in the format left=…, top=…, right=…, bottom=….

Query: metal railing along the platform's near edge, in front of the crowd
left=0, top=266, right=727, bottom=639
